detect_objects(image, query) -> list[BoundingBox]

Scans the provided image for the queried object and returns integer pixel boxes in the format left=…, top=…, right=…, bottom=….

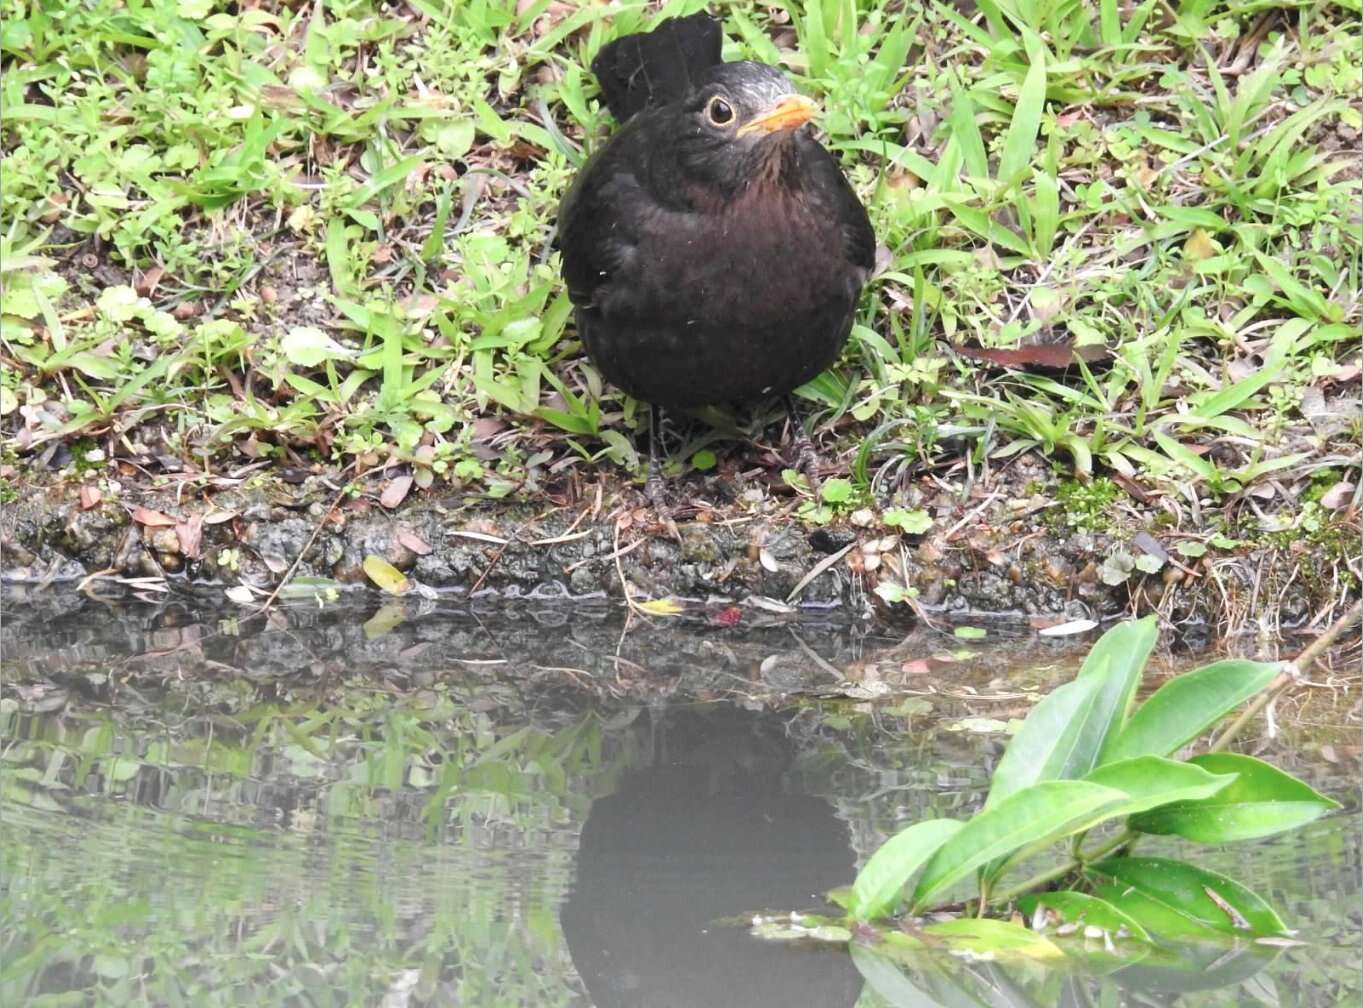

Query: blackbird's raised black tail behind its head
left=592, top=14, right=724, bottom=123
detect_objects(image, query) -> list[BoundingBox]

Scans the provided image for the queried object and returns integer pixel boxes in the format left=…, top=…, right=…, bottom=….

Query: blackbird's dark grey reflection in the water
left=563, top=706, right=861, bottom=1008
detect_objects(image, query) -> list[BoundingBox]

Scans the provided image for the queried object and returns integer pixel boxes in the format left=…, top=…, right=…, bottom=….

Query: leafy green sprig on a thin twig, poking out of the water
left=759, top=608, right=1359, bottom=1003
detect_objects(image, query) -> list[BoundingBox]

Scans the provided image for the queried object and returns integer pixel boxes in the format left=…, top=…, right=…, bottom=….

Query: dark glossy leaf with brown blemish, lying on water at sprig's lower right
left=1085, top=858, right=1285, bottom=939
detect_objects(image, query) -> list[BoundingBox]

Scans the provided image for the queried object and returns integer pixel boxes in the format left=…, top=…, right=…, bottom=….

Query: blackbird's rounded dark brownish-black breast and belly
left=578, top=175, right=864, bottom=407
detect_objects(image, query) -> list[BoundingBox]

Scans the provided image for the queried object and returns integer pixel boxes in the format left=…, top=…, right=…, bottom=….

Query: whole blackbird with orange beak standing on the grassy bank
left=559, top=14, right=875, bottom=496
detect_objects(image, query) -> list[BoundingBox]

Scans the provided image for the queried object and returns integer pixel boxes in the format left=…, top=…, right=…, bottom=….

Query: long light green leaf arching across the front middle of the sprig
left=912, top=781, right=1127, bottom=910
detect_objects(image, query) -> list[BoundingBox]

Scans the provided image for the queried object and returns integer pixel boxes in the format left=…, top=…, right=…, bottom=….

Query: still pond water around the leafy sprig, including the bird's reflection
left=0, top=588, right=1363, bottom=1008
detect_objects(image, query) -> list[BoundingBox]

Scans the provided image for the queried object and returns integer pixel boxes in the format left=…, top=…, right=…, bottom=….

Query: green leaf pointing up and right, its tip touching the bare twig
left=1100, top=659, right=1281, bottom=763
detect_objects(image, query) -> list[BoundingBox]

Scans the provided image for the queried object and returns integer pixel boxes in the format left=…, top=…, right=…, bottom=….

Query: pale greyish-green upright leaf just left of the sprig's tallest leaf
left=984, top=676, right=1103, bottom=808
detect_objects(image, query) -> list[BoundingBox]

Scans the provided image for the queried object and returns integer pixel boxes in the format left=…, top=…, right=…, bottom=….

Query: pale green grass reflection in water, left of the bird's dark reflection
left=0, top=687, right=631, bottom=1005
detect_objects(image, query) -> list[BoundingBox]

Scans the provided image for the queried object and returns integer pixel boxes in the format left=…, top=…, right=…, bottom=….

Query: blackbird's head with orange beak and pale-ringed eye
left=676, top=63, right=818, bottom=195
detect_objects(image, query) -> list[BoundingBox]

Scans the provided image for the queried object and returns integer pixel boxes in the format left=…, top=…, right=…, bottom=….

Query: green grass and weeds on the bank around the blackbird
left=0, top=0, right=1363, bottom=531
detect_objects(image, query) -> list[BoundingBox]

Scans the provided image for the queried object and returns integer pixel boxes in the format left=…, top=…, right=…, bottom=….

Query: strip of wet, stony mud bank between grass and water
left=0, top=477, right=1356, bottom=637
